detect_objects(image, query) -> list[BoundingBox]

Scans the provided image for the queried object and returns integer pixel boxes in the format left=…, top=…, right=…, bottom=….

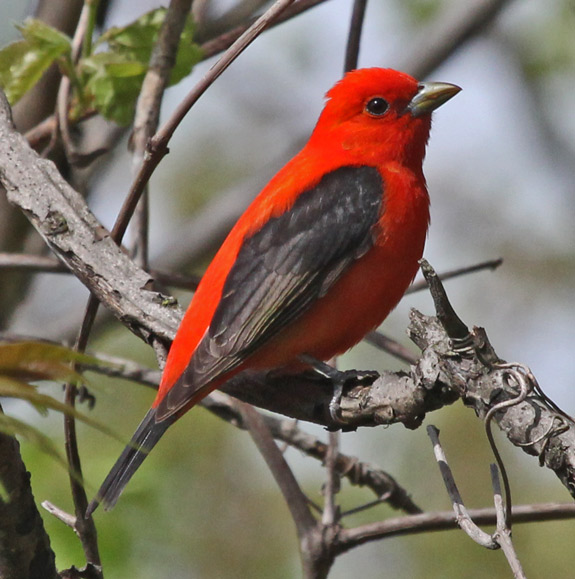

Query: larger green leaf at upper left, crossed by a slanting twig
left=80, top=8, right=202, bottom=125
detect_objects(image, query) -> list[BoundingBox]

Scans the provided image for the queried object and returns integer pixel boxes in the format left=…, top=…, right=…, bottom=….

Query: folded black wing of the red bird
left=158, top=167, right=384, bottom=418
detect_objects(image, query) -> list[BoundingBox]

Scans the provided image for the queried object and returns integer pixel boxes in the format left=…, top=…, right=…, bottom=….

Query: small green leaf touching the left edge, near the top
left=0, top=18, right=71, bottom=104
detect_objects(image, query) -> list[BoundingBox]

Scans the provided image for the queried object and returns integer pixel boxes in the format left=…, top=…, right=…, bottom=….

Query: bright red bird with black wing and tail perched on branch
left=88, top=68, right=460, bottom=515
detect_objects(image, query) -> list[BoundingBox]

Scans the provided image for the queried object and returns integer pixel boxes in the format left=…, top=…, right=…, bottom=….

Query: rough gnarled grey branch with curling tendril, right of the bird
left=409, top=310, right=575, bottom=496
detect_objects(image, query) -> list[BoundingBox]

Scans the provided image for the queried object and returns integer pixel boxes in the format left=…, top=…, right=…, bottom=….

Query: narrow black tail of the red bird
left=86, top=408, right=176, bottom=517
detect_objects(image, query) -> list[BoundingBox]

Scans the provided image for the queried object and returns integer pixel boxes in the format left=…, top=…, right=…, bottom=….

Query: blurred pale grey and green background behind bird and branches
left=0, top=0, right=575, bottom=579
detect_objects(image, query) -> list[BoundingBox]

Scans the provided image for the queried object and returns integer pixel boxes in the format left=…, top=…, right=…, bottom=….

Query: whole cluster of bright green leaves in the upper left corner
left=0, top=8, right=202, bottom=125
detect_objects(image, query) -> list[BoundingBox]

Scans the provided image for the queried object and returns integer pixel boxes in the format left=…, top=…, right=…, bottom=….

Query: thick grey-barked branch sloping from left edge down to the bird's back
left=0, top=88, right=179, bottom=341
